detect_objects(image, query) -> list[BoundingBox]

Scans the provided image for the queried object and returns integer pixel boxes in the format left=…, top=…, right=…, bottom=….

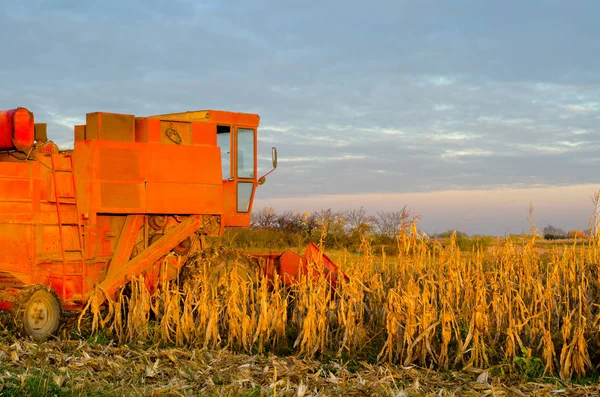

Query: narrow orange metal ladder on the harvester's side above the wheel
left=50, top=154, right=85, bottom=299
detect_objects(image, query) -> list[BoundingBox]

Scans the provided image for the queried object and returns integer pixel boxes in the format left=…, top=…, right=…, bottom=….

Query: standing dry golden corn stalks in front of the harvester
left=82, top=223, right=600, bottom=379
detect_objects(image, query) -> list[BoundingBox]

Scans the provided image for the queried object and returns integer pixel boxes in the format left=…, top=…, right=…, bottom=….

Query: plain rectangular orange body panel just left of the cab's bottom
left=146, top=182, right=223, bottom=214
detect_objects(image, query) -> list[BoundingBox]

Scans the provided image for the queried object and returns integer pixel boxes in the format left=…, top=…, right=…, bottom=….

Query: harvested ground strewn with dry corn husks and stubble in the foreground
left=0, top=333, right=600, bottom=397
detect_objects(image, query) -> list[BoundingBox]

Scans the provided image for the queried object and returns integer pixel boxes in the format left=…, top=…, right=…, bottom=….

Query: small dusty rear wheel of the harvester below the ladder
left=12, top=285, right=61, bottom=341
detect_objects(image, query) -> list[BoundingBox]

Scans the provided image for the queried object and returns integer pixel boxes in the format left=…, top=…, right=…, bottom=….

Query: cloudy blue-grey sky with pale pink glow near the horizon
left=0, top=0, right=600, bottom=235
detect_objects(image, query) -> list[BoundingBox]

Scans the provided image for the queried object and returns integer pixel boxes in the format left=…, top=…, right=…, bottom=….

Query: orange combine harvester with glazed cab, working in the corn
left=0, top=108, right=339, bottom=340
